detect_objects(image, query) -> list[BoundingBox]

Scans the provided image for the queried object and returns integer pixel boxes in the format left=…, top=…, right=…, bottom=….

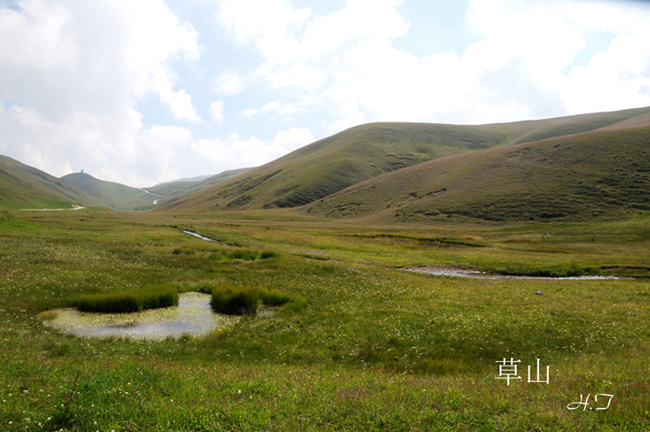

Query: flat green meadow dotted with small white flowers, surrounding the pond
left=0, top=210, right=650, bottom=431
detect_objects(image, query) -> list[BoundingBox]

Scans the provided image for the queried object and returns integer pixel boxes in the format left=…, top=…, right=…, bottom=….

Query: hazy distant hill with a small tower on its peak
left=61, top=173, right=157, bottom=211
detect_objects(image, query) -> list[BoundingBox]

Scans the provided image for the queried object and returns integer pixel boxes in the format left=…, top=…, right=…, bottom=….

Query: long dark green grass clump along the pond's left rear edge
left=73, top=287, right=178, bottom=313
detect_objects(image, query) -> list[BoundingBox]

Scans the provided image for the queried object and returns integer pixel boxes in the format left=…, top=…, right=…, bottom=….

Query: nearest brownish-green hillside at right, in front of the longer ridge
left=305, top=127, right=650, bottom=221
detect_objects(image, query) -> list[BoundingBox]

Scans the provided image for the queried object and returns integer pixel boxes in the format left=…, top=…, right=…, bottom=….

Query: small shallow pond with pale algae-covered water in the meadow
left=45, top=293, right=239, bottom=339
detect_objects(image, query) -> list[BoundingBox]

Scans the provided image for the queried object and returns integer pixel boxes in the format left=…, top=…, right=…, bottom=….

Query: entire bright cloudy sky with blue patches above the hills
left=0, top=0, right=650, bottom=187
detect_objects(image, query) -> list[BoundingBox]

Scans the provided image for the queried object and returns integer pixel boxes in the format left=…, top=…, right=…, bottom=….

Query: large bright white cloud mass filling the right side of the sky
left=217, top=0, right=650, bottom=128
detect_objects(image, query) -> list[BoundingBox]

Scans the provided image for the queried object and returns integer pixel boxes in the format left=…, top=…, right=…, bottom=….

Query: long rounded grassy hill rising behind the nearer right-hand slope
left=167, top=108, right=650, bottom=210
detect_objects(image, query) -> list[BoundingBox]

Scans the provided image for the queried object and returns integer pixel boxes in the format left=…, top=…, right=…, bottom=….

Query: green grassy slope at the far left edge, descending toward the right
left=0, top=155, right=102, bottom=209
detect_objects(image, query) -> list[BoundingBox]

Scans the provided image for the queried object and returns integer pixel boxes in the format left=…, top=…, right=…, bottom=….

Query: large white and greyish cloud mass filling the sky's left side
left=0, top=0, right=200, bottom=185
